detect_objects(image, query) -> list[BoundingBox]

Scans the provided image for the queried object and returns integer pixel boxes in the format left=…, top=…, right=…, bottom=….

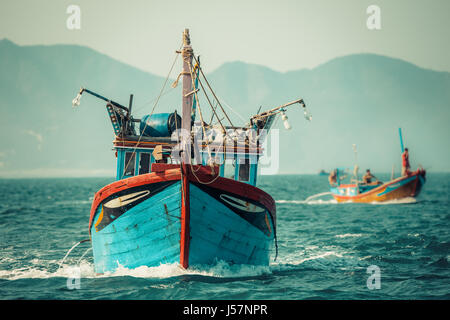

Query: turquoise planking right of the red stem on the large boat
left=189, top=184, right=274, bottom=265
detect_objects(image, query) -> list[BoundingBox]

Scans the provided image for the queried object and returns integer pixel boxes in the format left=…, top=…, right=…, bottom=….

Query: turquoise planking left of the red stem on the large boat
left=91, top=182, right=181, bottom=273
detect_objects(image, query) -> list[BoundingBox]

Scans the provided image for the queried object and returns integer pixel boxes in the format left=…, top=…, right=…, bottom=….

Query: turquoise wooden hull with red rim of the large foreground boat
left=89, top=164, right=276, bottom=273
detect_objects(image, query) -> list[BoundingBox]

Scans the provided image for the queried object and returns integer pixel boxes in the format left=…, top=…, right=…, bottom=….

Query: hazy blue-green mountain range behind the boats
left=0, top=39, right=450, bottom=176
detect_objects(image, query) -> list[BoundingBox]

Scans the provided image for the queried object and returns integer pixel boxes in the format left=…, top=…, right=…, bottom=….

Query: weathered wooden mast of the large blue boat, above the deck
left=181, top=29, right=193, bottom=163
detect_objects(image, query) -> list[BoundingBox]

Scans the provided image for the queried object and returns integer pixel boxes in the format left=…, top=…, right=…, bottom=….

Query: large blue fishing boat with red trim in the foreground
left=73, top=29, right=310, bottom=273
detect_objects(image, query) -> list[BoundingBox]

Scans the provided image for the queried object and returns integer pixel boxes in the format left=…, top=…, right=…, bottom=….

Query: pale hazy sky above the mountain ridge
left=0, top=0, right=450, bottom=76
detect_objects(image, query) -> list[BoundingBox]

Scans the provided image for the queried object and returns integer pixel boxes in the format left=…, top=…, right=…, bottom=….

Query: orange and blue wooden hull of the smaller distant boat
left=331, top=170, right=426, bottom=203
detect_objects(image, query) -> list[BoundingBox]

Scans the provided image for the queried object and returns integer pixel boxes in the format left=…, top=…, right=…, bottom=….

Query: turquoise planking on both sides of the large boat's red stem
left=91, top=182, right=274, bottom=273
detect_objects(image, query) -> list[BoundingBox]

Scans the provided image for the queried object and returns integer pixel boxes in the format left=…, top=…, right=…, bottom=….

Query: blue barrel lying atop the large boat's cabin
left=139, top=112, right=181, bottom=137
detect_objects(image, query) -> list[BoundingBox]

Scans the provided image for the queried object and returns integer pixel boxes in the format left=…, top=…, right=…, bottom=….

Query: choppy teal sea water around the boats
left=0, top=173, right=450, bottom=300
